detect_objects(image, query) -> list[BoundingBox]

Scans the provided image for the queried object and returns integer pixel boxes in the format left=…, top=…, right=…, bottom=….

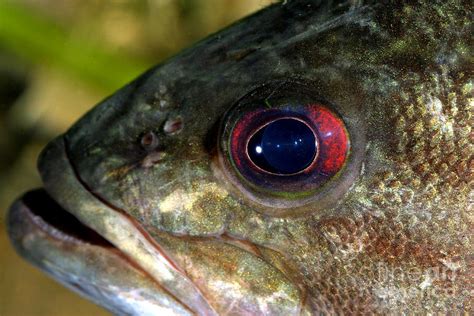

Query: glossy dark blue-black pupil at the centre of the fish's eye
left=247, top=118, right=317, bottom=175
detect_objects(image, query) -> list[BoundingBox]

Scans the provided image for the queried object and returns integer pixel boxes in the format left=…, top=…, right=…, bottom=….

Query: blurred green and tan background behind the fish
left=0, top=0, right=272, bottom=316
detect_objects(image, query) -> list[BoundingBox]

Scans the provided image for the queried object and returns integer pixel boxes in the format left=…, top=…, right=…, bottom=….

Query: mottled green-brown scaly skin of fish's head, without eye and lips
left=5, top=0, right=474, bottom=313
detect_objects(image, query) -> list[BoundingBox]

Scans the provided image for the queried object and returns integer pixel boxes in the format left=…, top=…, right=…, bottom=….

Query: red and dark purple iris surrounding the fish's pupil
left=229, top=104, right=349, bottom=192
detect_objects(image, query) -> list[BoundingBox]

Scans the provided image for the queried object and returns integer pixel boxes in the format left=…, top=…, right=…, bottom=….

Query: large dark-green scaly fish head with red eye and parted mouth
left=7, top=0, right=474, bottom=315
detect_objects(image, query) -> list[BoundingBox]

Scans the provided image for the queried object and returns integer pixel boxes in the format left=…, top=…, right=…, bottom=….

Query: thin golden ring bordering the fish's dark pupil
left=245, top=115, right=319, bottom=177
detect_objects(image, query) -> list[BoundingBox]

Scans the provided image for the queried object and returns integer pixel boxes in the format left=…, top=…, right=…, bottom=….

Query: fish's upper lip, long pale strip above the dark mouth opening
left=38, top=137, right=217, bottom=315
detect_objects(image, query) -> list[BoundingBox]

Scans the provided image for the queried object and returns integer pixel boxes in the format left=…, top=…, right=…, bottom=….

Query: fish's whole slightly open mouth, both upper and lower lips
left=7, top=137, right=217, bottom=315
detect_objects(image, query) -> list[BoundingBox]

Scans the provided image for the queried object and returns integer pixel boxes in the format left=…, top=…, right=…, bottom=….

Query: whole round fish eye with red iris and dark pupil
left=221, top=81, right=351, bottom=210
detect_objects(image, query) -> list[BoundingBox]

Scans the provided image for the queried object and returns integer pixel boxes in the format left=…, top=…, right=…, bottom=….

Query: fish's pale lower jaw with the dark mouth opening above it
left=8, top=189, right=198, bottom=315
